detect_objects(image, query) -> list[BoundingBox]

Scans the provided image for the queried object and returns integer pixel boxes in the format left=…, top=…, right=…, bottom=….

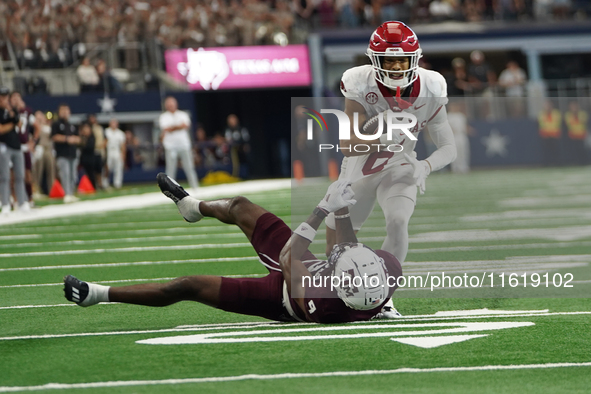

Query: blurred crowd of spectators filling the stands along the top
left=0, top=0, right=591, bottom=69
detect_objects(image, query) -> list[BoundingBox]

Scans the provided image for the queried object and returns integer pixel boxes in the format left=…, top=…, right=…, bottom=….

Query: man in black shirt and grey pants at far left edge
left=0, top=87, right=30, bottom=215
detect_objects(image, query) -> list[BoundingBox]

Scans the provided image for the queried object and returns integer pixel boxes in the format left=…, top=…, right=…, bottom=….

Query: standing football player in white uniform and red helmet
left=326, top=22, right=456, bottom=276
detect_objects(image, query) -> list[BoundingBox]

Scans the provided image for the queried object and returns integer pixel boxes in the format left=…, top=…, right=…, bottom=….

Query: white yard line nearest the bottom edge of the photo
left=0, top=362, right=591, bottom=393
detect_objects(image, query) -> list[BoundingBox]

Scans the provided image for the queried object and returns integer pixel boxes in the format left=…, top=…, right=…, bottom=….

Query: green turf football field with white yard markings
left=0, top=168, right=591, bottom=394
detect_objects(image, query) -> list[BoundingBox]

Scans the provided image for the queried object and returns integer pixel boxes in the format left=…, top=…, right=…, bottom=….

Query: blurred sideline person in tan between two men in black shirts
left=33, top=111, right=55, bottom=197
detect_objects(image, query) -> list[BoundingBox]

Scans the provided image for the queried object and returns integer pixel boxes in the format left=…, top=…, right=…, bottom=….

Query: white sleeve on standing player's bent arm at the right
left=427, top=107, right=457, bottom=171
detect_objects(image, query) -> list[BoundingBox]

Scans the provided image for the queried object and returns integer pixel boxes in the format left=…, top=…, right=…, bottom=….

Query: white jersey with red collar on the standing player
left=341, top=65, right=448, bottom=182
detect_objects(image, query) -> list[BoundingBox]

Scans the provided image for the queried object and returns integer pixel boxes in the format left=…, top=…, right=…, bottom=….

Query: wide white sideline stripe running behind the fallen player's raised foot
left=0, top=179, right=291, bottom=226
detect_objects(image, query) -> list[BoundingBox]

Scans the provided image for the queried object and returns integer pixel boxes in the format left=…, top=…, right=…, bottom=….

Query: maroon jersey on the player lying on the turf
left=289, top=250, right=402, bottom=323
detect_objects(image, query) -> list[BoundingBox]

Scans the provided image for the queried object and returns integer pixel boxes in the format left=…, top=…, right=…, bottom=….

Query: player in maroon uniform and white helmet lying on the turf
left=64, top=173, right=402, bottom=323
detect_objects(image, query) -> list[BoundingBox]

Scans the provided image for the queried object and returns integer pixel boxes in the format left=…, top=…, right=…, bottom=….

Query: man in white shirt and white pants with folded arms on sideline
left=160, top=96, right=199, bottom=190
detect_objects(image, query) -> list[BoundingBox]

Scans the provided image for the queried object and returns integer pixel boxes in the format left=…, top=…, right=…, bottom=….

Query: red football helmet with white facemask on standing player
left=367, top=21, right=422, bottom=89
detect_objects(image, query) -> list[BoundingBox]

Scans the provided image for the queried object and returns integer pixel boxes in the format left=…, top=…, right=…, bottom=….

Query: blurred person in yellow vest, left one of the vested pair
left=538, top=100, right=562, bottom=166
